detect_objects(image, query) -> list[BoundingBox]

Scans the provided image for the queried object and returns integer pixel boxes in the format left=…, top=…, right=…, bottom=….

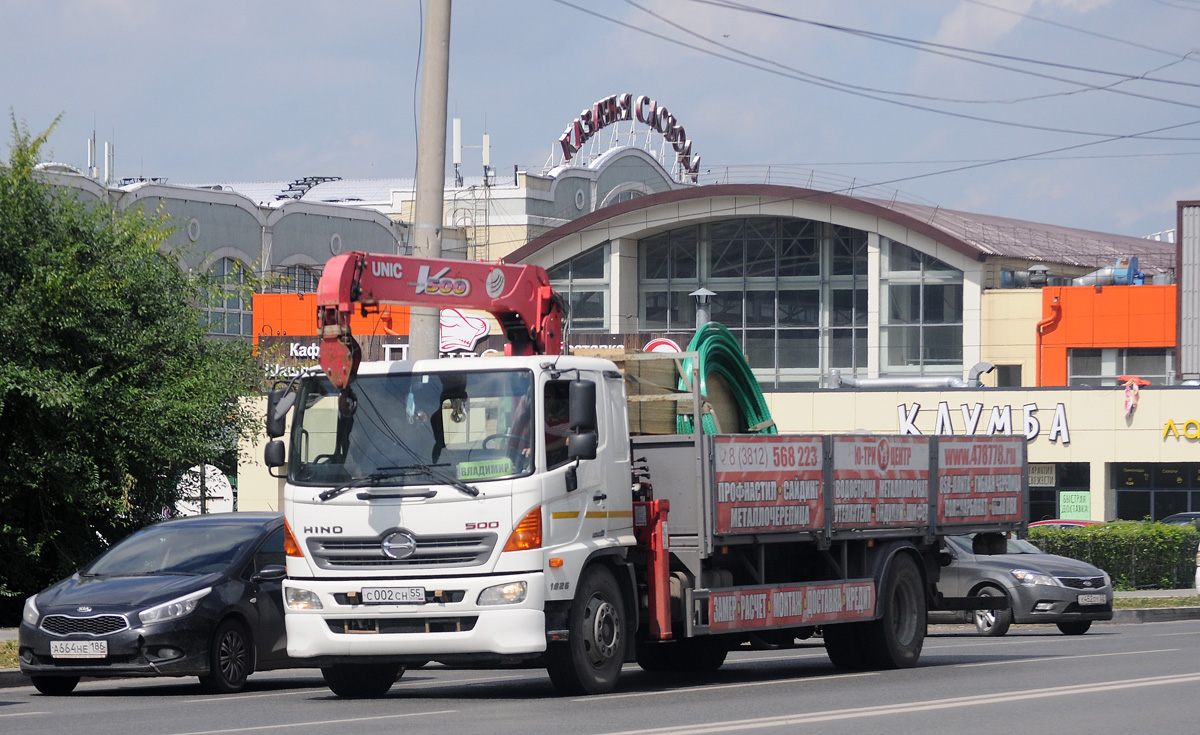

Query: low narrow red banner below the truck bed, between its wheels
left=708, top=579, right=875, bottom=632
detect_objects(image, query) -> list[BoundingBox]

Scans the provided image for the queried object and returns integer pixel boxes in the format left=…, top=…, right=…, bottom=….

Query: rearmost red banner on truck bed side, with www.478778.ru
left=937, top=436, right=1025, bottom=526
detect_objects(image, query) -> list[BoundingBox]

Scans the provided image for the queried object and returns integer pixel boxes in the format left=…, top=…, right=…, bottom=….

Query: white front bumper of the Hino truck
left=283, top=573, right=546, bottom=664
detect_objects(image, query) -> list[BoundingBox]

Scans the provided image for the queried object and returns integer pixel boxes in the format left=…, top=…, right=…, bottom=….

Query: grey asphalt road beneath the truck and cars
left=0, top=620, right=1200, bottom=735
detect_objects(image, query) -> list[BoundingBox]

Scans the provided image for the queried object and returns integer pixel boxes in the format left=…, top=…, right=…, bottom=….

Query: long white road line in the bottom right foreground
left=592, top=673, right=1200, bottom=735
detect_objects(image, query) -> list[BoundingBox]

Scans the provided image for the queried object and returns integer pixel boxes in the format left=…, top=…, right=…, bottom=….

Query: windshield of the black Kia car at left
left=83, top=524, right=260, bottom=576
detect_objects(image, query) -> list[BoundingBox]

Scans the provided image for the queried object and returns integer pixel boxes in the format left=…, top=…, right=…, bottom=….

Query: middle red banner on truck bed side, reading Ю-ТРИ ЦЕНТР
left=832, top=436, right=929, bottom=530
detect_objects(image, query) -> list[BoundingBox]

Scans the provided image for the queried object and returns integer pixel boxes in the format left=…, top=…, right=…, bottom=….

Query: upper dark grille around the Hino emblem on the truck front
left=308, top=528, right=497, bottom=569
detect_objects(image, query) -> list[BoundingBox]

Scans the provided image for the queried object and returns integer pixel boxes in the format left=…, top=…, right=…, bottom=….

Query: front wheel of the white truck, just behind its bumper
left=546, top=566, right=626, bottom=694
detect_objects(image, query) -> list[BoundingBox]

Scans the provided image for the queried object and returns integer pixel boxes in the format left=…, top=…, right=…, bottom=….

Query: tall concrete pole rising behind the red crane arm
left=408, top=0, right=450, bottom=360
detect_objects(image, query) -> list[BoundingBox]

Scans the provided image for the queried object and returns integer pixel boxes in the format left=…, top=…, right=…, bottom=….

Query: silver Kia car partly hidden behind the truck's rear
left=930, top=536, right=1112, bottom=635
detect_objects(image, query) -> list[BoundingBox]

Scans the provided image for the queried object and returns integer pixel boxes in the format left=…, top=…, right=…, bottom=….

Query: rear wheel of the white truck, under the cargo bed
left=863, top=554, right=928, bottom=669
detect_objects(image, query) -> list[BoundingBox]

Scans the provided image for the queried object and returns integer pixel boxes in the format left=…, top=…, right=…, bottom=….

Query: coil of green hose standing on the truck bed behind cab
left=676, top=322, right=778, bottom=434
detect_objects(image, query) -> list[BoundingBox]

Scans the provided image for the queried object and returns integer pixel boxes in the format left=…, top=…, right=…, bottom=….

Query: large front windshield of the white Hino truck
left=288, top=370, right=534, bottom=485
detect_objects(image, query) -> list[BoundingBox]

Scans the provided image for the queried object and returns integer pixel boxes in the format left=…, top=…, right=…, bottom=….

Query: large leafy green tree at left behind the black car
left=0, top=120, right=257, bottom=625
